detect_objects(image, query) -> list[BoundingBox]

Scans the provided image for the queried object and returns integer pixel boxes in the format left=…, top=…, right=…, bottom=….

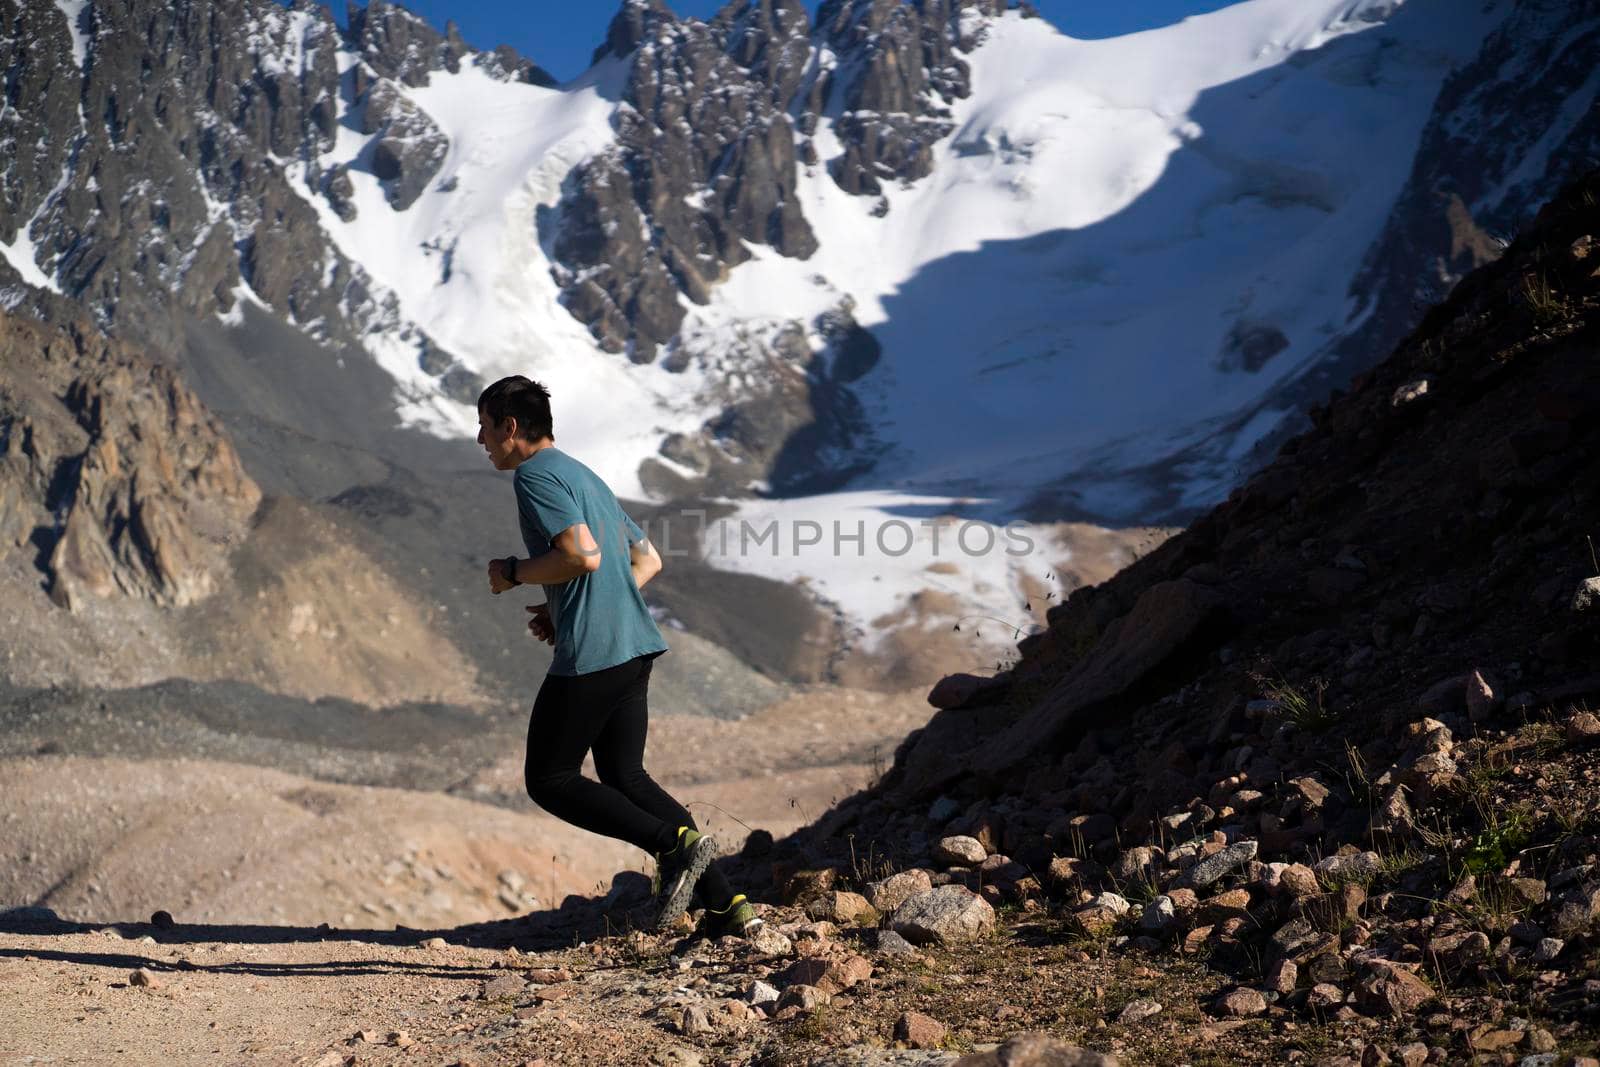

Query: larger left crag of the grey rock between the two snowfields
left=555, top=0, right=816, bottom=362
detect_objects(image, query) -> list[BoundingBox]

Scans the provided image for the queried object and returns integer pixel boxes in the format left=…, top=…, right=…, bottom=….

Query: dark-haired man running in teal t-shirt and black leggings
left=478, top=374, right=762, bottom=936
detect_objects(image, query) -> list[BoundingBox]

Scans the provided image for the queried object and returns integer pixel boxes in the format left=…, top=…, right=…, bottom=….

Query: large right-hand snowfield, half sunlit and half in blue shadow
left=690, top=0, right=1504, bottom=520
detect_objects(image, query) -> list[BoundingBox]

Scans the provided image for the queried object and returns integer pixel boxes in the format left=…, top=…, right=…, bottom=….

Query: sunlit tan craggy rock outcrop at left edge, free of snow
left=0, top=317, right=261, bottom=609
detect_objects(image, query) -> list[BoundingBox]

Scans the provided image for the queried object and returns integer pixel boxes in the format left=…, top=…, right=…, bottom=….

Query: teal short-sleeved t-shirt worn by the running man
left=514, top=445, right=667, bottom=675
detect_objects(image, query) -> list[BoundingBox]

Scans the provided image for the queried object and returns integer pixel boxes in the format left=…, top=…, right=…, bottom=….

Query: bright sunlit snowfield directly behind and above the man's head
left=281, top=59, right=704, bottom=498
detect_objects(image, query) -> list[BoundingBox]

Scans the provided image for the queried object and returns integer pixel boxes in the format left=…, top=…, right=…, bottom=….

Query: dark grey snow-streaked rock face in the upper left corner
left=0, top=0, right=540, bottom=394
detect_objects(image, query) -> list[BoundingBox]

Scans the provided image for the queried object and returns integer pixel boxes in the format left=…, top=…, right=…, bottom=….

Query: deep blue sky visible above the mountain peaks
left=350, top=0, right=1235, bottom=80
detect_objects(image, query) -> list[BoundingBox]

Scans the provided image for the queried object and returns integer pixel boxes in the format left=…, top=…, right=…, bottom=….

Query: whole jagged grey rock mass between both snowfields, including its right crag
left=554, top=0, right=1005, bottom=365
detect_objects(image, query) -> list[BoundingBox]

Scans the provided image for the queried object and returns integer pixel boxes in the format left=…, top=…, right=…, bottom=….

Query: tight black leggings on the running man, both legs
left=523, top=653, right=733, bottom=907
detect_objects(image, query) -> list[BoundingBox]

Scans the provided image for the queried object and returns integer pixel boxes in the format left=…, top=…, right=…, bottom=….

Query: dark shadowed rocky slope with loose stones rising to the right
left=643, top=173, right=1600, bottom=1064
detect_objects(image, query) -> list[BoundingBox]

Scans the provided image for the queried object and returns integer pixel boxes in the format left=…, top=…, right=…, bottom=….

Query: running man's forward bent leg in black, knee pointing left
left=523, top=664, right=678, bottom=853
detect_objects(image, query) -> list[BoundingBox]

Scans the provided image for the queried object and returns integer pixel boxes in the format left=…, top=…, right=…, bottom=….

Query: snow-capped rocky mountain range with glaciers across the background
left=0, top=0, right=1600, bottom=652
